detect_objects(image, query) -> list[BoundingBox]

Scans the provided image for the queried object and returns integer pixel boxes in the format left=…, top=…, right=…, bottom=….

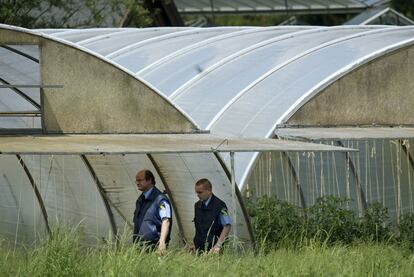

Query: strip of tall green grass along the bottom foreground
left=0, top=229, right=414, bottom=276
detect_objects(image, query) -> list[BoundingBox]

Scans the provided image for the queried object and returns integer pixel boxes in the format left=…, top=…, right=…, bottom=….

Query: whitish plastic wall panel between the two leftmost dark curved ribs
left=22, top=155, right=112, bottom=244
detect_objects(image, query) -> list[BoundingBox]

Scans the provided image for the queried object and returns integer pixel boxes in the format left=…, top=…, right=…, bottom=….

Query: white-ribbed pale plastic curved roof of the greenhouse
left=33, top=26, right=414, bottom=187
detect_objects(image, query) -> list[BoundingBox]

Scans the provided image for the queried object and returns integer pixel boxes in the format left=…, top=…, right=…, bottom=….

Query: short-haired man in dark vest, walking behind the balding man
left=194, top=179, right=231, bottom=253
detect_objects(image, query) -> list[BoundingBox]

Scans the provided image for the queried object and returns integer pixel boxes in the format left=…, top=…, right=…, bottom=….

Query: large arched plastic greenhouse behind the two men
left=0, top=25, right=414, bottom=244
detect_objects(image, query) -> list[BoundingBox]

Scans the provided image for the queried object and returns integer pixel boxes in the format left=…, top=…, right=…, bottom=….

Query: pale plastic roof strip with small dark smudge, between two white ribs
left=137, top=26, right=310, bottom=97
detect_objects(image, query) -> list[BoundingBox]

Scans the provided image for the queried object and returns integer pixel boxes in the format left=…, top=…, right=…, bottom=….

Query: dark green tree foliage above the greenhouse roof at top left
left=0, top=0, right=152, bottom=28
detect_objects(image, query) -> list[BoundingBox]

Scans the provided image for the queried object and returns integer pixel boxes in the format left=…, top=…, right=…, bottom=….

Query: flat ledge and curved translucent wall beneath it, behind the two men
left=0, top=134, right=354, bottom=245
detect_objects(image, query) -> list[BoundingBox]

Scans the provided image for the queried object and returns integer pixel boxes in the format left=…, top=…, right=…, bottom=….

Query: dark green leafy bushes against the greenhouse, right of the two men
left=247, top=193, right=404, bottom=251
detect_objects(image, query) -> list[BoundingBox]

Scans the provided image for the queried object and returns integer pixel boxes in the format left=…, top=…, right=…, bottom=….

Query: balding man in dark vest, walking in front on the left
left=133, top=169, right=172, bottom=254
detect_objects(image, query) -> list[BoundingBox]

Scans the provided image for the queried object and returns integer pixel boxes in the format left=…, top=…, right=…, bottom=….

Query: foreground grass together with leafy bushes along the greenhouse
left=0, top=197, right=414, bottom=276
